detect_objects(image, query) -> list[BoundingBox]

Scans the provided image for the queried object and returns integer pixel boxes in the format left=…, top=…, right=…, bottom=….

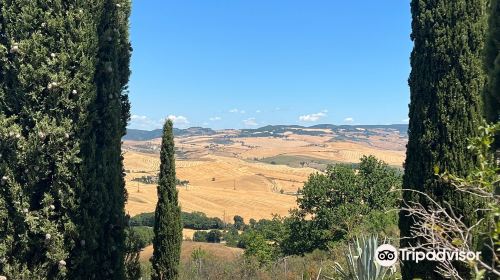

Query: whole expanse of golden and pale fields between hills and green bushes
left=123, top=131, right=405, bottom=222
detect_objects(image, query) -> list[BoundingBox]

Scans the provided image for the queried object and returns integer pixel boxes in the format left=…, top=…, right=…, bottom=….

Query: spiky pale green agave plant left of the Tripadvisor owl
left=327, top=236, right=395, bottom=280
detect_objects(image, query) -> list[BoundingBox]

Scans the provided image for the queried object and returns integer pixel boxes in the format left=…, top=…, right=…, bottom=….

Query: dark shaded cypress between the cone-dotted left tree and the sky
left=71, top=0, right=131, bottom=279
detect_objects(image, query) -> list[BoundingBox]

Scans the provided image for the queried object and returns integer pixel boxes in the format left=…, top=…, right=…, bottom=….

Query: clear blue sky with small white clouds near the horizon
left=129, top=0, right=412, bottom=129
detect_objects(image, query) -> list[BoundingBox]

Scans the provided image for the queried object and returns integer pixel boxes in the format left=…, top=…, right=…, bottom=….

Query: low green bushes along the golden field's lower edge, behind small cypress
left=129, top=212, right=224, bottom=230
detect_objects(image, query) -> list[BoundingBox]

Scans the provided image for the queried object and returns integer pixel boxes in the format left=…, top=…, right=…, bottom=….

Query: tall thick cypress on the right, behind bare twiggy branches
left=400, top=0, right=487, bottom=279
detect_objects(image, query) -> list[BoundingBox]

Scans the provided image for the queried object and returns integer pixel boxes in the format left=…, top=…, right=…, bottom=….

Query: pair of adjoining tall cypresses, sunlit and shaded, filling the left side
left=0, top=0, right=131, bottom=279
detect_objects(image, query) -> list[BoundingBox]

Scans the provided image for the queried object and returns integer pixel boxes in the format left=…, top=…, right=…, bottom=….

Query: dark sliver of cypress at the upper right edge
left=484, top=0, right=500, bottom=122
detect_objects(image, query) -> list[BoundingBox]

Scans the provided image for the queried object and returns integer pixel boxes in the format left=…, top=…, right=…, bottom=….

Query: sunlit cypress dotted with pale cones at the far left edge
left=0, top=0, right=97, bottom=279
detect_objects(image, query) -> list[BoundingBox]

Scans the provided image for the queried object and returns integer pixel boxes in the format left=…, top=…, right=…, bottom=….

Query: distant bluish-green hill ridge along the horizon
left=123, top=124, right=408, bottom=141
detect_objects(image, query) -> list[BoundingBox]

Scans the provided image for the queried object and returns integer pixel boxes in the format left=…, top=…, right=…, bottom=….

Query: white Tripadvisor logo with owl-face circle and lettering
left=375, top=244, right=481, bottom=267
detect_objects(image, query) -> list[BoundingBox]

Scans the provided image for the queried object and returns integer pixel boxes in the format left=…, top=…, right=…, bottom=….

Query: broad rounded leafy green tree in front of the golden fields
left=280, top=156, right=401, bottom=254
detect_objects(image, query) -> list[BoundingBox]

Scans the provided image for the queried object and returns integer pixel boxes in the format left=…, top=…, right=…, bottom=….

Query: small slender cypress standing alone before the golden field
left=152, top=120, right=182, bottom=280
